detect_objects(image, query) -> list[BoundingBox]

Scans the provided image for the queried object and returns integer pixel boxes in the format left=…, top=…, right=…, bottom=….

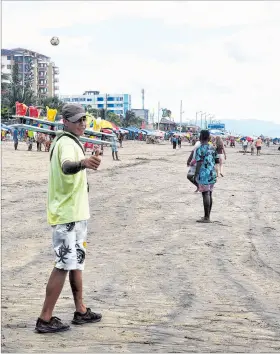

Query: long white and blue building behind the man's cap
left=60, top=91, right=131, bottom=116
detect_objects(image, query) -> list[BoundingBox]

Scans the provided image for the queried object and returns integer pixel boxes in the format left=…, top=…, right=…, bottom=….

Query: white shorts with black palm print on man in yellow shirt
left=52, top=220, right=87, bottom=270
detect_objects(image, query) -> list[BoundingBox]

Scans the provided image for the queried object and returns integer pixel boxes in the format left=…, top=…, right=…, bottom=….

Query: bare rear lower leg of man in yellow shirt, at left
left=40, top=268, right=68, bottom=321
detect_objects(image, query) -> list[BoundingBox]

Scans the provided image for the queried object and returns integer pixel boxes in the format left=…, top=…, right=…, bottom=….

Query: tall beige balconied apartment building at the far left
left=1, top=48, right=59, bottom=97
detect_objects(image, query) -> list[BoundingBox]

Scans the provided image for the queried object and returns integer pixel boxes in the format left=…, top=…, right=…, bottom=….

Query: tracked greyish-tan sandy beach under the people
left=2, top=141, right=280, bottom=353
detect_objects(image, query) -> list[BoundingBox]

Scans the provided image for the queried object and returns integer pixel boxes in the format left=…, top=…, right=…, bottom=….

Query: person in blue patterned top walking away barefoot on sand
left=194, top=130, right=217, bottom=223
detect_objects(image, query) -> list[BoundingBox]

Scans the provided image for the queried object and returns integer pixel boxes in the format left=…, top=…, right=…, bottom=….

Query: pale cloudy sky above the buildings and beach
left=2, top=1, right=280, bottom=123
